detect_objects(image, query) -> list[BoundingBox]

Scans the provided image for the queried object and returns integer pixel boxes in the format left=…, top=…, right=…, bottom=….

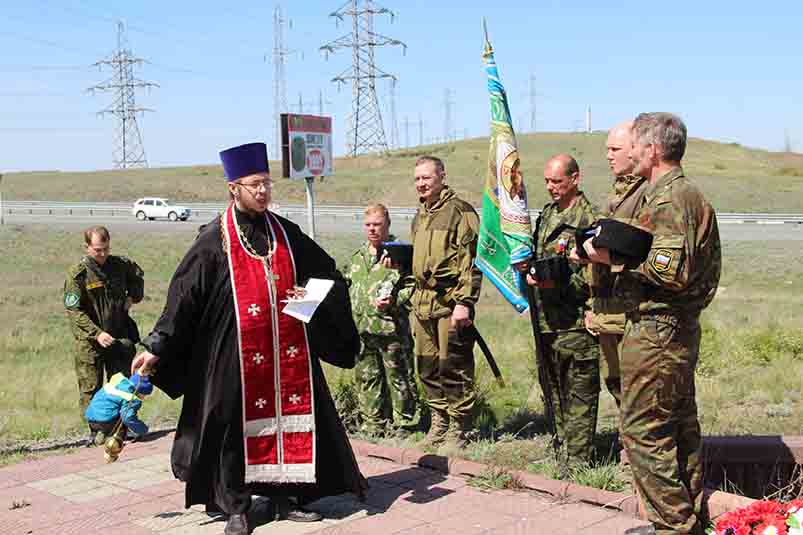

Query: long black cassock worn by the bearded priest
left=142, top=210, right=367, bottom=514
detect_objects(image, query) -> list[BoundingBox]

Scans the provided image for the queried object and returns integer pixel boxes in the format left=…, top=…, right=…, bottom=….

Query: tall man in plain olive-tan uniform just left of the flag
left=406, top=156, right=482, bottom=448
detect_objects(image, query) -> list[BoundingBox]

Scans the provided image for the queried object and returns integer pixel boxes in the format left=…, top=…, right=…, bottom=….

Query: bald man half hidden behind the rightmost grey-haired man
left=585, top=121, right=647, bottom=407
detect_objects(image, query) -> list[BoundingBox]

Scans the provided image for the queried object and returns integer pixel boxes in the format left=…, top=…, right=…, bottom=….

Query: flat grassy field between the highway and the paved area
left=0, top=226, right=803, bottom=490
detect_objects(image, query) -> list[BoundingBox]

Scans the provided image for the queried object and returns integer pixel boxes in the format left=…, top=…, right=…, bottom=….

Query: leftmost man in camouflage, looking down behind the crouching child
left=64, top=226, right=145, bottom=440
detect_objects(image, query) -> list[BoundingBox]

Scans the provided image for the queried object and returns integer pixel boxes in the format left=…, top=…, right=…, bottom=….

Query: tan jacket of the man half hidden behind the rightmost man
left=586, top=175, right=647, bottom=322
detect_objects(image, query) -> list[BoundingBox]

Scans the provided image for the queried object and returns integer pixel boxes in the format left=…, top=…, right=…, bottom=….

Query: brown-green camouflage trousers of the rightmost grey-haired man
left=621, top=316, right=704, bottom=535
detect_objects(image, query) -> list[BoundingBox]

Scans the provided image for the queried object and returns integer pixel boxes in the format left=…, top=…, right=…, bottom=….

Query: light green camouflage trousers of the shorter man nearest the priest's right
left=354, top=335, right=418, bottom=433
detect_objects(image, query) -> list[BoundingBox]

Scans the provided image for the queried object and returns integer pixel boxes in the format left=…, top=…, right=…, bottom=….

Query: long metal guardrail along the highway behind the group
left=3, top=201, right=803, bottom=225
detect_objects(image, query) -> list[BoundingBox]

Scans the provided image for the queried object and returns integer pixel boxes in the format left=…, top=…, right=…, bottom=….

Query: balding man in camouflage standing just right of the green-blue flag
left=527, top=154, right=600, bottom=470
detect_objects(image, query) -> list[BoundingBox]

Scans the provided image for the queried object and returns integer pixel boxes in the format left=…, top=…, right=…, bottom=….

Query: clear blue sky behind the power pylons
left=0, top=0, right=803, bottom=172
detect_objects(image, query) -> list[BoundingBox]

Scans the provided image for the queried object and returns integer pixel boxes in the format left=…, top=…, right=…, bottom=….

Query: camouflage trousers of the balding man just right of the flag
left=541, top=331, right=600, bottom=463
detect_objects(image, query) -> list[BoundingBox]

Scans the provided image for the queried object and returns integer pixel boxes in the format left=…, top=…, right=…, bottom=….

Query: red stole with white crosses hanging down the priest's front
left=221, top=203, right=316, bottom=483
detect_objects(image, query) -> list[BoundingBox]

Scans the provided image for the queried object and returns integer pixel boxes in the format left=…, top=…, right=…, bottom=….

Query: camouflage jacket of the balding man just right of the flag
left=535, top=192, right=598, bottom=333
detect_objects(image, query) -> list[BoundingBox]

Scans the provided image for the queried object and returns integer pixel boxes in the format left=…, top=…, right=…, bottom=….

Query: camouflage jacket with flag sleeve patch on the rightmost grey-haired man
left=613, top=167, right=722, bottom=316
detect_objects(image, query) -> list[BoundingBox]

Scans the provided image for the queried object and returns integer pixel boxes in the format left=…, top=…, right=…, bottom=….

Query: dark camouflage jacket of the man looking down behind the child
left=63, top=255, right=145, bottom=342
